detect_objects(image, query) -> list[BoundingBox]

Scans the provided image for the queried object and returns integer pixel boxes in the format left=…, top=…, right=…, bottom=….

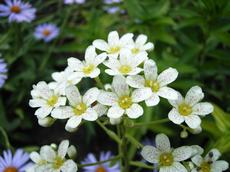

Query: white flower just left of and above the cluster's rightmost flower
left=126, top=59, right=178, bottom=106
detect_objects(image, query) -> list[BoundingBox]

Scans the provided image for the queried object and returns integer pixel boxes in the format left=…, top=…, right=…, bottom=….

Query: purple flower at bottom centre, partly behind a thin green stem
left=82, top=151, right=120, bottom=172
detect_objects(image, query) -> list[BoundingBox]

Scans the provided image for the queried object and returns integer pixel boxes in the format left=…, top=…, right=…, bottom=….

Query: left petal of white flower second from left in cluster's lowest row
left=51, top=106, right=74, bottom=119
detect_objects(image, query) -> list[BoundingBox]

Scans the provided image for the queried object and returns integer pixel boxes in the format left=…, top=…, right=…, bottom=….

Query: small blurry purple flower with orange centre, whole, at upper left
left=34, top=23, right=59, bottom=42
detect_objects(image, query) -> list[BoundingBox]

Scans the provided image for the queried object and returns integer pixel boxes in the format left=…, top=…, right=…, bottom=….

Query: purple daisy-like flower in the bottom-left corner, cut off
left=0, top=149, right=32, bottom=172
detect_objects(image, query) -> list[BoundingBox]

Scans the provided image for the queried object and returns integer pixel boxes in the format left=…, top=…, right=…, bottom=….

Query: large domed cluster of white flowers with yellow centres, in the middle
left=29, top=31, right=213, bottom=131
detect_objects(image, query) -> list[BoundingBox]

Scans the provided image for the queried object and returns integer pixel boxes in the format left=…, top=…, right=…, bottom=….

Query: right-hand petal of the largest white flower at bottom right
left=173, top=146, right=192, bottom=161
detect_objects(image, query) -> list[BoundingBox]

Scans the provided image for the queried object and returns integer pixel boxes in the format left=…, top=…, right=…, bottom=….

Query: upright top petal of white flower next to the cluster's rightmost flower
left=144, top=59, right=157, bottom=81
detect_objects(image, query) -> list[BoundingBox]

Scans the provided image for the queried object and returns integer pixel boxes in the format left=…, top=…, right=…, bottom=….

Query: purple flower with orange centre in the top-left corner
left=0, top=0, right=36, bottom=23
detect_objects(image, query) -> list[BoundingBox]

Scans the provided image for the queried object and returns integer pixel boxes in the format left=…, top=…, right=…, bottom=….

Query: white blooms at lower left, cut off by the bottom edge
left=30, top=140, right=78, bottom=172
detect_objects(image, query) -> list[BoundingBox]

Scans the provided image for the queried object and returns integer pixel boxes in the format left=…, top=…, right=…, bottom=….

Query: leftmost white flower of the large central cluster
left=29, top=81, right=66, bottom=119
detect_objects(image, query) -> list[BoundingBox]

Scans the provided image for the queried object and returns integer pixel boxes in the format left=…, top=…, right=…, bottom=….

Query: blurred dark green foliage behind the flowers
left=0, top=0, right=230, bottom=168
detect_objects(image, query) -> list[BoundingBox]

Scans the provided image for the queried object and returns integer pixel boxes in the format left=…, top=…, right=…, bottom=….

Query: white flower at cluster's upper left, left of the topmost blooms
left=68, top=46, right=106, bottom=78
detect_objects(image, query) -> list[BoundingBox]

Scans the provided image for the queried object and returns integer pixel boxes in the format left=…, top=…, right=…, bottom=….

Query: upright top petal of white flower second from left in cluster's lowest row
left=66, top=85, right=81, bottom=106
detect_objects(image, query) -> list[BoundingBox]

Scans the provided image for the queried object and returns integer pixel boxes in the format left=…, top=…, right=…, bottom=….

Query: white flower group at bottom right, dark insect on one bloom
left=141, top=134, right=229, bottom=172
